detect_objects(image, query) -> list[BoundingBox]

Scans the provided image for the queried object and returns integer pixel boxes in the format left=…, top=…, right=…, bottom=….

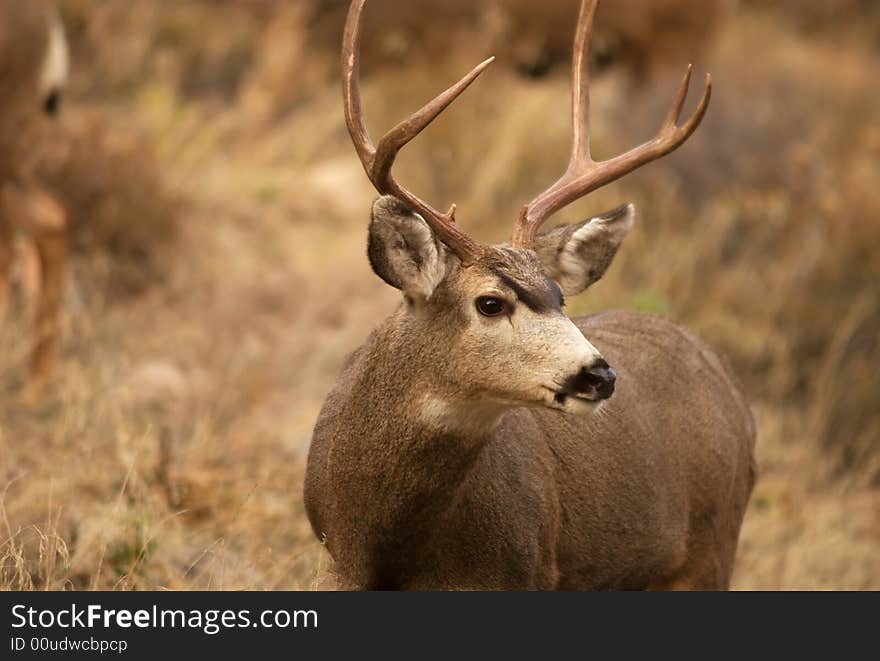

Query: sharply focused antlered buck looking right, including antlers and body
left=304, top=0, right=755, bottom=589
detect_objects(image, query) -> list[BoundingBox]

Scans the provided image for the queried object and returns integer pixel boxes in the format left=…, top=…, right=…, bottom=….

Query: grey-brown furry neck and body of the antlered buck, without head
left=305, top=262, right=755, bottom=589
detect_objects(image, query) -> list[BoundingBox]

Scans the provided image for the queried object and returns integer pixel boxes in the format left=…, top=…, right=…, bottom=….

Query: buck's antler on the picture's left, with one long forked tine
left=342, top=0, right=495, bottom=264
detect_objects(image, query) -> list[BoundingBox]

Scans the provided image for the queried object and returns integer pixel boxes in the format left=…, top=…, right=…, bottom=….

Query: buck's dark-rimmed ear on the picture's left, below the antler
left=367, top=195, right=446, bottom=300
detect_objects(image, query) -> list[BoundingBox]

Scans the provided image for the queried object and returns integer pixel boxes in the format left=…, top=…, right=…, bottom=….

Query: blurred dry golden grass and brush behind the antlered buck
left=0, top=0, right=880, bottom=589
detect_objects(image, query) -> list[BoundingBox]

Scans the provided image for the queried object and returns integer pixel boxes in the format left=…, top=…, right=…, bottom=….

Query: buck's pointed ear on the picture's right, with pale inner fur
left=535, top=204, right=636, bottom=296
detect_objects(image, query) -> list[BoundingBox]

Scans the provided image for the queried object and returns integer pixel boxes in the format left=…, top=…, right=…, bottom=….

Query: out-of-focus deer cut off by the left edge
left=0, top=0, right=68, bottom=393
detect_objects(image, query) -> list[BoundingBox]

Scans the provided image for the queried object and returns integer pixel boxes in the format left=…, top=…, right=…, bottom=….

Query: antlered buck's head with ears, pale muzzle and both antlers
left=342, top=0, right=711, bottom=412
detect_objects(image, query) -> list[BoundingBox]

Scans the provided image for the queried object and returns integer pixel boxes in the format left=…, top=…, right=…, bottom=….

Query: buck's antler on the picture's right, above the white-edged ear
left=511, top=0, right=712, bottom=248
